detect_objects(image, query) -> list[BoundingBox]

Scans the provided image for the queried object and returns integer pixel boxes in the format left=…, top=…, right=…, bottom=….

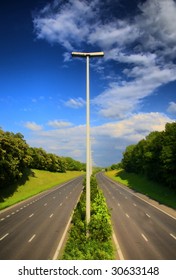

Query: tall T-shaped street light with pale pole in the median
left=72, top=52, right=104, bottom=225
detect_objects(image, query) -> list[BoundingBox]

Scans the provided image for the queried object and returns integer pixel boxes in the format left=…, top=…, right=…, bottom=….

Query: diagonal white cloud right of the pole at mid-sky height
left=92, top=66, right=176, bottom=118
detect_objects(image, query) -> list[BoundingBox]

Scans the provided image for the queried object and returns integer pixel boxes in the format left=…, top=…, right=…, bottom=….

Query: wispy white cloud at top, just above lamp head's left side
left=33, top=0, right=97, bottom=50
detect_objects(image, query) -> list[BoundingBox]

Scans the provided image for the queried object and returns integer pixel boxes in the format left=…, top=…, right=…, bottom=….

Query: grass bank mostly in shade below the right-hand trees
left=105, top=170, right=176, bottom=209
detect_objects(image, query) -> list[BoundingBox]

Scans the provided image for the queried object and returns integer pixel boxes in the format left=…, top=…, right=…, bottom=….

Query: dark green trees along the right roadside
left=121, top=122, right=176, bottom=189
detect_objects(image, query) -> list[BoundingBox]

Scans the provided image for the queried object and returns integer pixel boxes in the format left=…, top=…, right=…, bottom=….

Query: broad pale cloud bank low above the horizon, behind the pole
left=28, top=113, right=173, bottom=166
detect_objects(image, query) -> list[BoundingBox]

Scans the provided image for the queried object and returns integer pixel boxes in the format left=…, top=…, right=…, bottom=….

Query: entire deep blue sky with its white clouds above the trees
left=0, top=0, right=176, bottom=166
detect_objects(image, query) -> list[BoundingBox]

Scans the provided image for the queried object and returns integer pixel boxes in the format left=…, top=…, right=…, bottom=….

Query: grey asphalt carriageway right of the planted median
left=97, top=173, right=176, bottom=260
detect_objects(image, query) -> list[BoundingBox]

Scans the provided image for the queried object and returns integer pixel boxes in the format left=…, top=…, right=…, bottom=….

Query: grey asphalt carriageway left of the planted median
left=0, top=176, right=83, bottom=260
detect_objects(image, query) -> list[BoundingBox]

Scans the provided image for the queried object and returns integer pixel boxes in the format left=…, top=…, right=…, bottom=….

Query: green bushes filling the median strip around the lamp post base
left=62, top=176, right=114, bottom=260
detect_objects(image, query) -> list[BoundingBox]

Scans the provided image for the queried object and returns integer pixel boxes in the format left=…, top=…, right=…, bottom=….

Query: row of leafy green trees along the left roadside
left=0, top=129, right=86, bottom=187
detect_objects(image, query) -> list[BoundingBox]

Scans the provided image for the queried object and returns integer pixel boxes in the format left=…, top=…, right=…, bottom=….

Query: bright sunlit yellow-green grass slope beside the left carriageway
left=0, top=169, right=84, bottom=209
